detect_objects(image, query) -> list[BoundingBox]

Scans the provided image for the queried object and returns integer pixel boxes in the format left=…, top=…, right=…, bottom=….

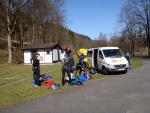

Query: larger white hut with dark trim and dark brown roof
left=22, top=43, right=67, bottom=65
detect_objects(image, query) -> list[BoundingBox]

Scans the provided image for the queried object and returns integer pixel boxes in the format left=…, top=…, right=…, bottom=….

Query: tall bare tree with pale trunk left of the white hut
left=0, top=0, right=21, bottom=63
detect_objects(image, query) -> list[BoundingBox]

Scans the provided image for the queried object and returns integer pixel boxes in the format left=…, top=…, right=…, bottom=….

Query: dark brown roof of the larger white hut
left=22, top=43, right=62, bottom=50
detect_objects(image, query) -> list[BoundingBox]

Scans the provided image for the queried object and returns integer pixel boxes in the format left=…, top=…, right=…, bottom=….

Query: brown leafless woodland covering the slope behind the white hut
left=0, top=0, right=99, bottom=59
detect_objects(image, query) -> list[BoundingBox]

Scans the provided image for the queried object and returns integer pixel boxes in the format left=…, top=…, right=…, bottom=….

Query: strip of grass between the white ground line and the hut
left=0, top=64, right=62, bottom=86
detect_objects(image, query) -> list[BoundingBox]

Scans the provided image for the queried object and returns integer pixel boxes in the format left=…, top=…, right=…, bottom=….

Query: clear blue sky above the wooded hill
left=65, top=0, right=126, bottom=39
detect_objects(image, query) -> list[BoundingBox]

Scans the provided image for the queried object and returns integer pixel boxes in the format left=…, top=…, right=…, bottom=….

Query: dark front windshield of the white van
left=103, top=49, right=123, bottom=58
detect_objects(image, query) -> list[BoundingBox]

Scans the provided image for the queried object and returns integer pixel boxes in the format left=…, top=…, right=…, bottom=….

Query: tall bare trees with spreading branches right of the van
left=120, top=0, right=150, bottom=56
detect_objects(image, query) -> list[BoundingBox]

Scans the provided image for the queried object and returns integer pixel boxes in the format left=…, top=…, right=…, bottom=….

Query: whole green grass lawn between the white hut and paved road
left=0, top=59, right=143, bottom=108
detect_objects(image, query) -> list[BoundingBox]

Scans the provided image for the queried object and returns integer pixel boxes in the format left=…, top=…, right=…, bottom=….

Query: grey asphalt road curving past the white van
left=0, top=59, right=150, bottom=113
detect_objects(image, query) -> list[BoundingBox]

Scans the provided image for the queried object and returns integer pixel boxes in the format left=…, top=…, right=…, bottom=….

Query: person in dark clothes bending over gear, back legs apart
left=62, top=61, right=71, bottom=86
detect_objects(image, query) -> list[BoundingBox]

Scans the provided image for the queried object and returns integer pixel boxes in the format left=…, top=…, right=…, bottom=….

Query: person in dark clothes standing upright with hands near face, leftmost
left=31, top=53, right=41, bottom=87
